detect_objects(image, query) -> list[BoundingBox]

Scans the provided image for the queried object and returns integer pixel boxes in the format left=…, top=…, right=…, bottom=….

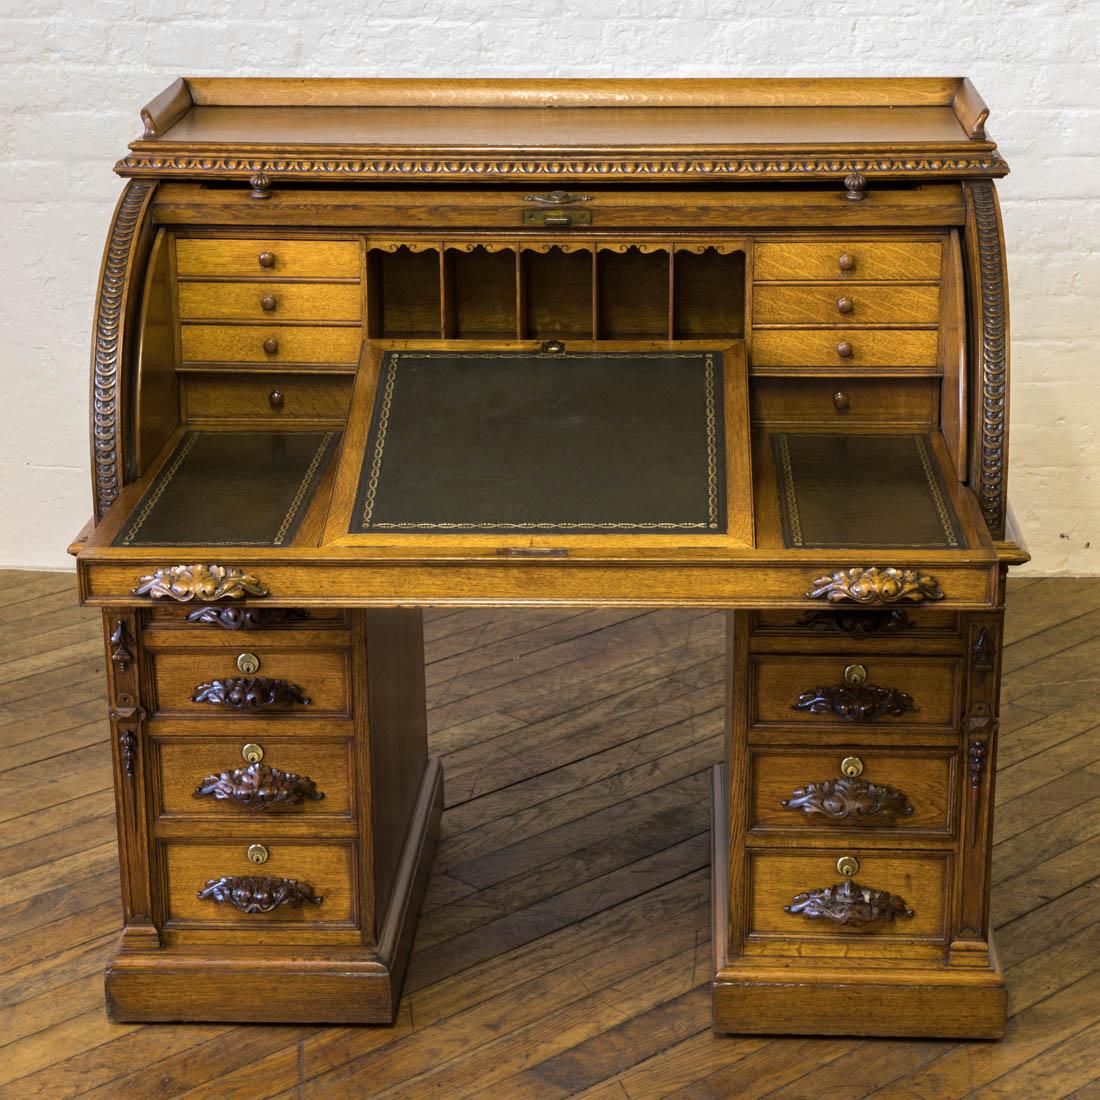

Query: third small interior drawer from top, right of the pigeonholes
left=752, top=329, right=939, bottom=371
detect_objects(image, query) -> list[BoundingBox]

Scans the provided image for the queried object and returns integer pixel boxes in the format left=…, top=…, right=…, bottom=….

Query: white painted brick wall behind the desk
left=0, top=0, right=1100, bottom=573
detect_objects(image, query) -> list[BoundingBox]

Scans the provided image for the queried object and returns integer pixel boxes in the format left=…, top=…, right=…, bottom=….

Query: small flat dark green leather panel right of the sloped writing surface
left=772, top=432, right=966, bottom=550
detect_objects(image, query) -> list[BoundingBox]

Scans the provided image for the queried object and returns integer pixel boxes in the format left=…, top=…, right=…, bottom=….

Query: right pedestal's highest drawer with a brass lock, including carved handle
left=750, top=653, right=959, bottom=728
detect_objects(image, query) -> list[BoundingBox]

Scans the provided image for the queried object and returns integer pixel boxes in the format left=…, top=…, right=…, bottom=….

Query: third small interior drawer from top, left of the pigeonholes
left=179, top=323, right=362, bottom=364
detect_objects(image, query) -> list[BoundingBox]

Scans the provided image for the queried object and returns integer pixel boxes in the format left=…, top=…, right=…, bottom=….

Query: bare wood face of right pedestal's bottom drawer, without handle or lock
left=749, top=846, right=949, bottom=939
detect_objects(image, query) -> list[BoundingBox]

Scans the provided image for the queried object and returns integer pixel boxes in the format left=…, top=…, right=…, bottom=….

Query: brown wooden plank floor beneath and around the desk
left=0, top=571, right=1100, bottom=1100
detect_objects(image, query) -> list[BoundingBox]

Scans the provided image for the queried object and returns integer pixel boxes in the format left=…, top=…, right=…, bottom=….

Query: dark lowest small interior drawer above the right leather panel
left=749, top=375, right=937, bottom=431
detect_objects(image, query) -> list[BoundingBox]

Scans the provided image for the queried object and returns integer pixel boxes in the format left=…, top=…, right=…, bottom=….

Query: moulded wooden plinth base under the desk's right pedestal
left=711, top=765, right=1008, bottom=1040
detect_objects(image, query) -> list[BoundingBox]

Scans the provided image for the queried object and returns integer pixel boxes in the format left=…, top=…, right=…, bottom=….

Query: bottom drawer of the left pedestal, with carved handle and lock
left=163, top=838, right=356, bottom=927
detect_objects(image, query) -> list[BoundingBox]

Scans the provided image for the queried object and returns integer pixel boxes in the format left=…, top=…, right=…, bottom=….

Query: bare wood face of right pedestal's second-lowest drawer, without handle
left=750, top=748, right=955, bottom=835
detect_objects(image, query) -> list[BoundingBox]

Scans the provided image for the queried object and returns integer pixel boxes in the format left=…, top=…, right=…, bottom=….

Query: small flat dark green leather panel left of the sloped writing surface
left=114, top=431, right=340, bottom=547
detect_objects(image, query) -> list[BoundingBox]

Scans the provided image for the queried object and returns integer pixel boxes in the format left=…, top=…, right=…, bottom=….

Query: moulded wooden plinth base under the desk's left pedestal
left=105, top=757, right=443, bottom=1024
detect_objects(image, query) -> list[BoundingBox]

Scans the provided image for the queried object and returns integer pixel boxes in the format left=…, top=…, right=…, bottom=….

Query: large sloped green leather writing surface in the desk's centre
left=350, top=351, right=726, bottom=535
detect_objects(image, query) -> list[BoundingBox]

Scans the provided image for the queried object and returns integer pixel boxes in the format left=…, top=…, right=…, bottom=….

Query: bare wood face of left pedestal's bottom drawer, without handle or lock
left=163, top=838, right=356, bottom=927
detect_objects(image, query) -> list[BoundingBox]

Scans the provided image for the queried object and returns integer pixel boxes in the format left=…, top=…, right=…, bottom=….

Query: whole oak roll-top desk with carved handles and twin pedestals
left=74, top=78, right=1026, bottom=1037
